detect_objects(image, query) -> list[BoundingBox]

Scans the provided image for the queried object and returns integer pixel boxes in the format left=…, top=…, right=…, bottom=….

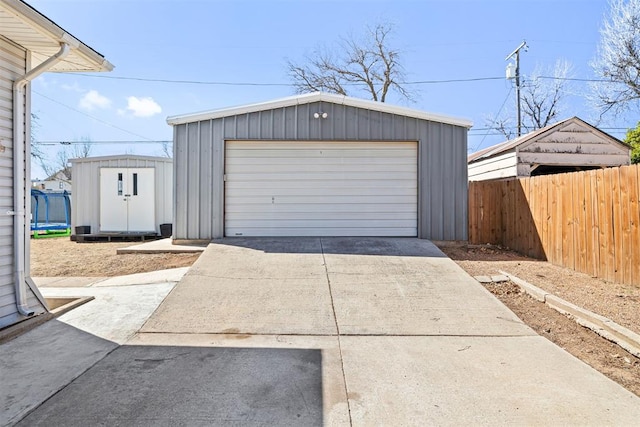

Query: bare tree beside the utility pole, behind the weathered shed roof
left=486, top=60, right=572, bottom=139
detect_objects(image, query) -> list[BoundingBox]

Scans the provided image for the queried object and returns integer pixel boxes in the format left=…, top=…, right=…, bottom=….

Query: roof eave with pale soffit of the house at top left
left=0, top=0, right=113, bottom=72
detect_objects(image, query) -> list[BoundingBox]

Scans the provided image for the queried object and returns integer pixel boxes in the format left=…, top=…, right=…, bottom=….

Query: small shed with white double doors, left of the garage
left=71, top=155, right=173, bottom=234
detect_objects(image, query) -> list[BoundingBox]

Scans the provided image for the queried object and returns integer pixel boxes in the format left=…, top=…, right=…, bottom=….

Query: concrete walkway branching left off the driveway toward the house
left=0, top=268, right=187, bottom=426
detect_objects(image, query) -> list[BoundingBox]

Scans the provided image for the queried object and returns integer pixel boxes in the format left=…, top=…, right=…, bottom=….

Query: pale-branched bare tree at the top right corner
left=591, top=0, right=640, bottom=114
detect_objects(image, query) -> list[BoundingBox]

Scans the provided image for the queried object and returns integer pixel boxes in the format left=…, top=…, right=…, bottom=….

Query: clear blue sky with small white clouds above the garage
left=27, top=0, right=624, bottom=178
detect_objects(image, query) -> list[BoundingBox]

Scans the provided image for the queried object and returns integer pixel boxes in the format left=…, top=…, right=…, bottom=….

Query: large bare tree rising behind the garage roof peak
left=287, top=24, right=413, bottom=102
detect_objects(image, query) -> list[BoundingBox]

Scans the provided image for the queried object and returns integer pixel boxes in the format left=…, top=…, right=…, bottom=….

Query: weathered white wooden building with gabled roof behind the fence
left=467, top=117, right=631, bottom=181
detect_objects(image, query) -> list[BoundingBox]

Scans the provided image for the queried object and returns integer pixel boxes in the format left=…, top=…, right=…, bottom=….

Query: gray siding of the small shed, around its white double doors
left=71, top=156, right=173, bottom=234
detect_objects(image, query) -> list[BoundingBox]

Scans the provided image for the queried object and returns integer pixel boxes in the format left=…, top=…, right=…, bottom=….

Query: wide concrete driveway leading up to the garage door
left=13, top=238, right=640, bottom=426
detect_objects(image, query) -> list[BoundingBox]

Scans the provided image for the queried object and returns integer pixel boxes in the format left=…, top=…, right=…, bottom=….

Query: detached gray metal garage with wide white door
left=167, top=93, right=471, bottom=242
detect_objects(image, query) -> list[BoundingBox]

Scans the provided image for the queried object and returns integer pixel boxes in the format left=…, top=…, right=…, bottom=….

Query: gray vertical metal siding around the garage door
left=174, top=102, right=467, bottom=240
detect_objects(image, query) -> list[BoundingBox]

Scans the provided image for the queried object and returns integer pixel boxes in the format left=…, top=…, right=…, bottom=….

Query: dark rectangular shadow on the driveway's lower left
left=18, top=345, right=323, bottom=426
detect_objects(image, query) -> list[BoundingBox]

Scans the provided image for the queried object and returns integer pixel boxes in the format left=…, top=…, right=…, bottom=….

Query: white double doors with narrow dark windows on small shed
left=100, top=168, right=156, bottom=232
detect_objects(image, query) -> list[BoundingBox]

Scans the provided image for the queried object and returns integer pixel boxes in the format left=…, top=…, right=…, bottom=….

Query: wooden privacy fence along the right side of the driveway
left=469, top=165, right=640, bottom=285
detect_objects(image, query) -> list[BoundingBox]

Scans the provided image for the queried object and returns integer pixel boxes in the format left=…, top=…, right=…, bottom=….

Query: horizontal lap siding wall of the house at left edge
left=0, top=36, right=44, bottom=328
